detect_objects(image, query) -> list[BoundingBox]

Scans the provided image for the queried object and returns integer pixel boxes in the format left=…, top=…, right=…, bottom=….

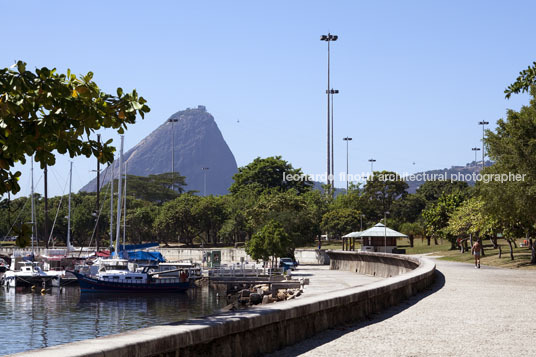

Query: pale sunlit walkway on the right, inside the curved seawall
left=273, top=260, right=536, bottom=357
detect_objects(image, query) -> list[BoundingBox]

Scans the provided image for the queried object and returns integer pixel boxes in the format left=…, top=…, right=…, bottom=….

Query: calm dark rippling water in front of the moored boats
left=0, top=280, right=225, bottom=354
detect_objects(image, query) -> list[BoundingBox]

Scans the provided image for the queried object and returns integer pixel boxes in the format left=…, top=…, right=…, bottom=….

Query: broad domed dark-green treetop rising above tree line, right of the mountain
left=229, top=156, right=312, bottom=194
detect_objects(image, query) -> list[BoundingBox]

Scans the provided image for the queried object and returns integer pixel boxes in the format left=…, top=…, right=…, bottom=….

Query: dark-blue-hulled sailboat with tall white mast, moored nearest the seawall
left=72, top=136, right=190, bottom=292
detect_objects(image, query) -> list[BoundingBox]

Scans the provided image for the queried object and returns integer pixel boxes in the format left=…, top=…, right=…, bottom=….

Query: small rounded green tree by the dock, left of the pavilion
left=246, top=220, right=292, bottom=261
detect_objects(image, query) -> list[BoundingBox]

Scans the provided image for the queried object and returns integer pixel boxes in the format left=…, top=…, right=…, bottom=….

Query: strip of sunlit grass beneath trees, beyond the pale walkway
left=398, top=238, right=536, bottom=270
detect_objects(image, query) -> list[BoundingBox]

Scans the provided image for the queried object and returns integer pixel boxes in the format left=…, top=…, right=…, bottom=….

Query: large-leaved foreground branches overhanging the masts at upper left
left=0, top=61, right=149, bottom=194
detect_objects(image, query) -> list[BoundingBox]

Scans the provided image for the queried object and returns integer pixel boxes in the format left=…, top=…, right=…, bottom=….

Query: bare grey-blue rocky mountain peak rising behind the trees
left=81, top=105, right=237, bottom=195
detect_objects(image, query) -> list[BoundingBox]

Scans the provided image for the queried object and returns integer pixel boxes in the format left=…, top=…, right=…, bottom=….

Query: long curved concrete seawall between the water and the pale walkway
left=14, top=251, right=435, bottom=357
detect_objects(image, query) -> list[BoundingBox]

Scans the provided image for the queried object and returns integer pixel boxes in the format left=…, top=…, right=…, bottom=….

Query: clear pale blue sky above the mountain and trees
left=0, top=0, right=536, bottom=196
